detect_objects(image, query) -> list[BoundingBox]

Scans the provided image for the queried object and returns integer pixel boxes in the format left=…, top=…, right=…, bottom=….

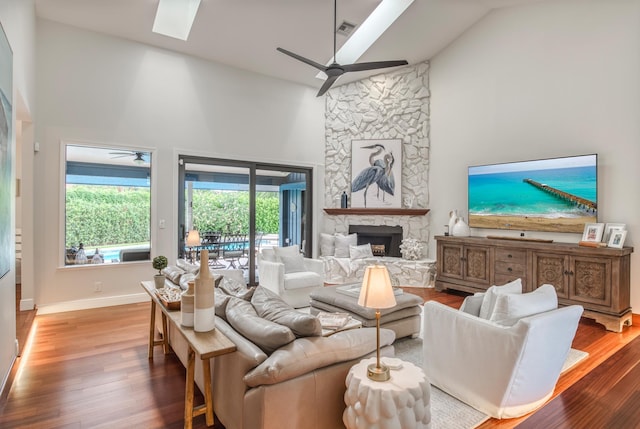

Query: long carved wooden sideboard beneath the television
left=435, top=236, right=633, bottom=332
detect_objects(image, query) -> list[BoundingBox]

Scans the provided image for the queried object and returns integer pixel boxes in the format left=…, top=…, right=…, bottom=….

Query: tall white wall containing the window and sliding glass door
left=35, top=20, right=324, bottom=311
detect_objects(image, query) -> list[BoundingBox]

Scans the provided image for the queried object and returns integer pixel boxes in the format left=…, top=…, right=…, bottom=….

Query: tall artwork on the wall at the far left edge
left=0, top=21, right=14, bottom=278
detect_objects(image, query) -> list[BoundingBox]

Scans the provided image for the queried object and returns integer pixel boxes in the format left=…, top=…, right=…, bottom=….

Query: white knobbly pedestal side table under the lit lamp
left=342, top=358, right=431, bottom=429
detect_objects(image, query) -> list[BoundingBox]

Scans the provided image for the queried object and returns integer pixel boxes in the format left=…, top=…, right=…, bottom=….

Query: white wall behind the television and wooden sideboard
left=429, top=0, right=640, bottom=313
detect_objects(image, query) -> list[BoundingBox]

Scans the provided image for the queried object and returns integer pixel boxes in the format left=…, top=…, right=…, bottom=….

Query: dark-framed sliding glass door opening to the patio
left=178, top=156, right=312, bottom=284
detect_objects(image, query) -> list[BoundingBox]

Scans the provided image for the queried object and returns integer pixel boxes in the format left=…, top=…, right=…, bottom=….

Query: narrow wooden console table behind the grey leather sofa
left=141, top=281, right=236, bottom=429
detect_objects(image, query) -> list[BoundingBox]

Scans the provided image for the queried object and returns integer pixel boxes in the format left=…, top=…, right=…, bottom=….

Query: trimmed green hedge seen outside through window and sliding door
left=66, top=185, right=279, bottom=248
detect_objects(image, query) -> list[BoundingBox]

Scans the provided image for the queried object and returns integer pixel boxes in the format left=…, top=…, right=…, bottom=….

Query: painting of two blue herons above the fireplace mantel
left=351, top=139, right=402, bottom=208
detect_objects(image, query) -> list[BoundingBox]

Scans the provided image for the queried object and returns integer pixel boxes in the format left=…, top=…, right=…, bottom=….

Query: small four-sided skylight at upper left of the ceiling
left=152, top=0, right=201, bottom=40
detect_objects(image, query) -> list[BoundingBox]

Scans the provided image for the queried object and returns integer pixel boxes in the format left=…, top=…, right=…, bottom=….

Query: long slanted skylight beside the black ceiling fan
left=316, top=0, right=414, bottom=80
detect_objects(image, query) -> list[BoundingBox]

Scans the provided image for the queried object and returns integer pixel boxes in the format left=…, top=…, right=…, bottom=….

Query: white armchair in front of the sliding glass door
left=258, top=246, right=324, bottom=308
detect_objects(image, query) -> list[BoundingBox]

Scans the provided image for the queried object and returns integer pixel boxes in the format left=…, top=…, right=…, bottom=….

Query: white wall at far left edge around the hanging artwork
left=0, top=0, right=35, bottom=394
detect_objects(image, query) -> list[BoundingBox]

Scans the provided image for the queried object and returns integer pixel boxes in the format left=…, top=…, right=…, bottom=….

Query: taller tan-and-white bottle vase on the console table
left=193, top=250, right=216, bottom=332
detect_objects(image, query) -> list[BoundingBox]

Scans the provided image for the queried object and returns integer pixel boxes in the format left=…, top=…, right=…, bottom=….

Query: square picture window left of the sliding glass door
left=63, top=144, right=151, bottom=265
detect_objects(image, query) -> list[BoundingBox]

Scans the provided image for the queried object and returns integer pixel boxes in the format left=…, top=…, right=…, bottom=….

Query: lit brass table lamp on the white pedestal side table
left=358, top=265, right=396, bottom=381
